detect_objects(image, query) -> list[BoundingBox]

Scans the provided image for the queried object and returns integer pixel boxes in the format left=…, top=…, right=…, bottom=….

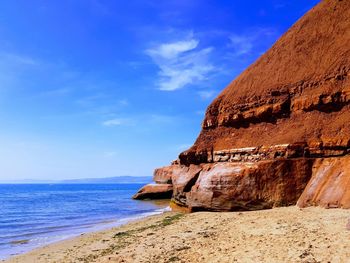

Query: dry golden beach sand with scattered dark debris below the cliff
left=6, top=207, right=350, bottom=263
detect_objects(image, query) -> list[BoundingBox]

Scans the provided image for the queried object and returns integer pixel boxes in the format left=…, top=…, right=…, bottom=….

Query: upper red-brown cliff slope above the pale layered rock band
left=185, top=0, right=350, bottom=156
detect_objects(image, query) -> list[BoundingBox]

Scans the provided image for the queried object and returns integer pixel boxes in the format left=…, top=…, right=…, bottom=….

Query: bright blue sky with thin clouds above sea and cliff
left=0, top=0, right=318, bottom=180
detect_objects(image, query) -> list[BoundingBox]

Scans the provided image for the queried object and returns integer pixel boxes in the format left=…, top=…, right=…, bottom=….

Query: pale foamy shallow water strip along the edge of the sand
left=0, top=200, right=171, bottom=262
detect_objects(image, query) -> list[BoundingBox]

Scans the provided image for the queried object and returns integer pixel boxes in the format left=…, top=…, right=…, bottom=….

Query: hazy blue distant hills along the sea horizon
left=0, top=176, right=152, bottom=184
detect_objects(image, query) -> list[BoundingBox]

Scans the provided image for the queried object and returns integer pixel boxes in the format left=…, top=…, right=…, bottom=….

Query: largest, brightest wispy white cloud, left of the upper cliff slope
left=146, top=37, right=214, bottom=91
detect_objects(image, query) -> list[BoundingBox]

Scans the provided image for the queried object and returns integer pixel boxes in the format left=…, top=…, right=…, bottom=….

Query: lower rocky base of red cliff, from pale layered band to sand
left=135, top=142, right=350, bottom=211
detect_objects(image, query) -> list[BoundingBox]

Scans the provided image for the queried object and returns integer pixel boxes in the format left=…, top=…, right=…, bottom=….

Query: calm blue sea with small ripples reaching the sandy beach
left=0, top=184, right=167, bottom=259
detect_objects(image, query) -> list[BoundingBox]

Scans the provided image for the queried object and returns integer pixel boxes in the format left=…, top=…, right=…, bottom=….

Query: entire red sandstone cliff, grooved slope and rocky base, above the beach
left=134, top=0, right=350, bottom=211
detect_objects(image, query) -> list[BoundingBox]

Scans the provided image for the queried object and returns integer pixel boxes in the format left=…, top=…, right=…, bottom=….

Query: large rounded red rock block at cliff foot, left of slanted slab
left=187, top=159, right=313, bottom=211
